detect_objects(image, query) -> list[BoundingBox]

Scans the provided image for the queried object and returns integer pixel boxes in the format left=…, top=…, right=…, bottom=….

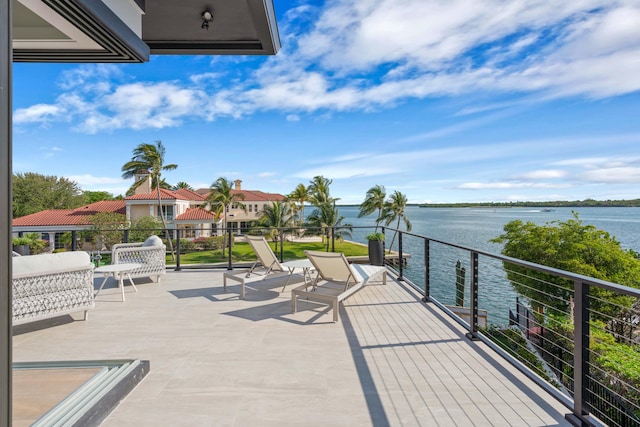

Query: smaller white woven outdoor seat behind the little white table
left=111, top=236, right=167, bottom=282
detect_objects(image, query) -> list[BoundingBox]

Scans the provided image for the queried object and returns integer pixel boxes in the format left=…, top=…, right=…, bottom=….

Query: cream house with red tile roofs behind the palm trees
left=13, top=174, right=285, bottom=249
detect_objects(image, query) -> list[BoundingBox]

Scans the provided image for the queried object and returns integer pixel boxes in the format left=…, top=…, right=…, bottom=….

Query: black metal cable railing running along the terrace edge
left=16, top=227, right=640, bottom=426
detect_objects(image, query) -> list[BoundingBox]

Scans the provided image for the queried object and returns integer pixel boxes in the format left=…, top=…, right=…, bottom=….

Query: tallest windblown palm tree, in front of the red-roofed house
left=122, top=141, right=178, bottom=258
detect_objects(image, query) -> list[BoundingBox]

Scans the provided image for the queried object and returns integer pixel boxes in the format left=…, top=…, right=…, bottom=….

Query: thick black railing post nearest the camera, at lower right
left=566, top=280, right=589, bottom=425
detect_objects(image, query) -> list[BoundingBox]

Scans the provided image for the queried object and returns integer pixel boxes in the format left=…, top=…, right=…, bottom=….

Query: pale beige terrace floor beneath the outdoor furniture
left=13, top=270, right=568, bottom=426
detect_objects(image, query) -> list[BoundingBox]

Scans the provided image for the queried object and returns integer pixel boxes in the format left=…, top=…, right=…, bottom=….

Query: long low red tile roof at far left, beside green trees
left=13, top=200, right=126, bottom=227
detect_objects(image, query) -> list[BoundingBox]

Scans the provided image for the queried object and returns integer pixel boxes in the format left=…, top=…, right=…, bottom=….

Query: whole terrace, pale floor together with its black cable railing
left=13, top=227, right=640, bottom=426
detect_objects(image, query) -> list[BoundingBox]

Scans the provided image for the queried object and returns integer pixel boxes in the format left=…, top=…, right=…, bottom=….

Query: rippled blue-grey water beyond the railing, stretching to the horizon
left=332, top=206, right=640, bottom=325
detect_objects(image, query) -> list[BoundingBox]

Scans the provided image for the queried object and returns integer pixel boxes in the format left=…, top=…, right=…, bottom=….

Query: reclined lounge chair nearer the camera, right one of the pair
left=291, top=251, right=387, bottom=322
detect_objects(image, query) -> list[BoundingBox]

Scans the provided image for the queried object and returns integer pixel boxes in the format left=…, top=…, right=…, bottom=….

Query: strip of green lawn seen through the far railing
left=167, top=240, right=368, bottom=264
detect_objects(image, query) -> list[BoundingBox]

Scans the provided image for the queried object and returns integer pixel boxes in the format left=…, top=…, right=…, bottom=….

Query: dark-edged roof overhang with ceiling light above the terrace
left=12, top=0, right=280, bottom=62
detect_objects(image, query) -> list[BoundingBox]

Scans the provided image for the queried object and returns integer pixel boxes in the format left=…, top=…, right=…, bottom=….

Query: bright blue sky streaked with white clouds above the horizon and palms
left=13, top=0, right=640, bottom=203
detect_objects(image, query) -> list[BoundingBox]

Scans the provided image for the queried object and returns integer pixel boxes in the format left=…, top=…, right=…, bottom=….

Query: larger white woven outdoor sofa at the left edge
left=12, top=252, right=95, bottom=325
